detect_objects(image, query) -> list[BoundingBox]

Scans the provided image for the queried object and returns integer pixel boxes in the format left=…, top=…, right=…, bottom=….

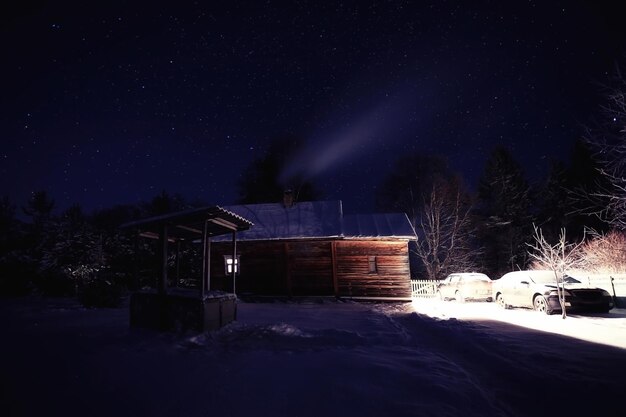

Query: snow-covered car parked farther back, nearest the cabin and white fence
left=437, top=272, right=492, bottom=303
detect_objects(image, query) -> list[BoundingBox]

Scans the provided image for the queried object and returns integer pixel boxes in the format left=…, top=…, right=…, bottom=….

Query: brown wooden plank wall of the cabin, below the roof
left=211, top=240, right=411, bottom=297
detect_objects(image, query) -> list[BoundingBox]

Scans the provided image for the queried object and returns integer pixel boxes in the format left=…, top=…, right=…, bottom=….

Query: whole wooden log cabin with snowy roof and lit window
left=210, top=201, right=415, bottom=299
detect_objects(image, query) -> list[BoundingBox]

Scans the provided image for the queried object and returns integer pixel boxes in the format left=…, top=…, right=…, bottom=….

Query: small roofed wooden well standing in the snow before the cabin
left=122, top=206, right=252, bottom=331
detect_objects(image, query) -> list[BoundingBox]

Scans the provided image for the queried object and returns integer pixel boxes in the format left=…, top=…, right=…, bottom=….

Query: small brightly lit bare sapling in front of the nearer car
left=527, top=225, right=583, bottom=318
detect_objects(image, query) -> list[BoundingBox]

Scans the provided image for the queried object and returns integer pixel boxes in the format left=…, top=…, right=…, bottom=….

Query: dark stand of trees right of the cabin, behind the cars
left=377, top=141, right=608, bottom=279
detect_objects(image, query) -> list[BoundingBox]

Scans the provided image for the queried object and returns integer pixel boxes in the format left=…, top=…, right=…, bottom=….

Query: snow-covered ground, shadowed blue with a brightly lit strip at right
left=0, top=298, right=626, bottom=417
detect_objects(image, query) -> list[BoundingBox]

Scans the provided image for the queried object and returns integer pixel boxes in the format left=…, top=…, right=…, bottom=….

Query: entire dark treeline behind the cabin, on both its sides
left=0, top=141, right=607, bottom=305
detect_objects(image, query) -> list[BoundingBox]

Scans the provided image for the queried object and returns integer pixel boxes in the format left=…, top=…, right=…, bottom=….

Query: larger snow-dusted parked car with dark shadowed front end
left=493, top=271, right=613, bottom=314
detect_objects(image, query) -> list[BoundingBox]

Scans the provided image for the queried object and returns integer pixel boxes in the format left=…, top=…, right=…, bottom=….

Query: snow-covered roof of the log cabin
left=215, top=200, right=415, bottom=241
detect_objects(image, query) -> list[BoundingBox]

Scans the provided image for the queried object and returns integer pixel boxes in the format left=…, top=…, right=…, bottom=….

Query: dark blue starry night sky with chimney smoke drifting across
left=0, top=1, right=626, bottom=212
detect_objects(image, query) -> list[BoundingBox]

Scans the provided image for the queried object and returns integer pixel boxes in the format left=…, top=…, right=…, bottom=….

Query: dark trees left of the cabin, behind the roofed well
left=0, top=191, right=201, bottom=306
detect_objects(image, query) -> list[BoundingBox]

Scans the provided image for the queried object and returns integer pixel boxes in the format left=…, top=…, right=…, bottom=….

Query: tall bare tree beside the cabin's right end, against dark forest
left=415, top=180, right=480, bottom=280
